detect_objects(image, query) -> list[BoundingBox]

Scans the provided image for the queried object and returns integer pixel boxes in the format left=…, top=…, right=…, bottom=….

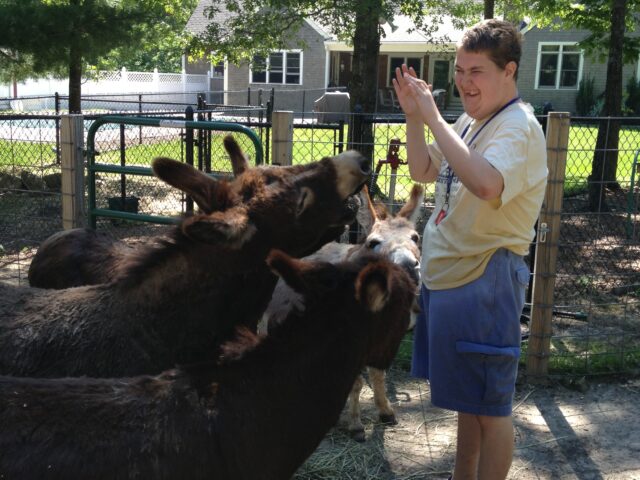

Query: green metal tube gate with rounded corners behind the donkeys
left=87, top=115, right=264, bottom=229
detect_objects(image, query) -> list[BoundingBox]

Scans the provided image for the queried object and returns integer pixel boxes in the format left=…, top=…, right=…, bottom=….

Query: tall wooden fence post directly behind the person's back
left=527, top=112, right=571, bottom=382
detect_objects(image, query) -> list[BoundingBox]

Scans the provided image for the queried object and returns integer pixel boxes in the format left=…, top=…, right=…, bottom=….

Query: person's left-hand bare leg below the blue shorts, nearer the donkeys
left=452, top=412, right=482, bottom=480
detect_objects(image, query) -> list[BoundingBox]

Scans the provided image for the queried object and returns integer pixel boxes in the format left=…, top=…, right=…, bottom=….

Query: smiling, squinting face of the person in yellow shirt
left=455, top=48, right=516, bottom=120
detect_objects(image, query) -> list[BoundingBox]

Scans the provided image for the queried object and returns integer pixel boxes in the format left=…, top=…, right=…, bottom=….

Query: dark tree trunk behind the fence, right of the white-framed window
left=589, top=0, right=627, bottom=212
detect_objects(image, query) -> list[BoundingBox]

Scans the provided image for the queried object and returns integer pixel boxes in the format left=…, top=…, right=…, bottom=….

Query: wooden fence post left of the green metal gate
left=60, top=115, right=86, bottom=230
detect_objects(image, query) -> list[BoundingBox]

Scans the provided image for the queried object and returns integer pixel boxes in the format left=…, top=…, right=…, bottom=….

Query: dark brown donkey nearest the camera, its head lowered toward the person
left=0, top=252, right=415, bottom=480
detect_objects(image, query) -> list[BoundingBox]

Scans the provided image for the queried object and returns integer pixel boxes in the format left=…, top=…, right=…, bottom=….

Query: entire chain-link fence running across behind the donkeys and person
left=0, top=105, right=640, bottom=376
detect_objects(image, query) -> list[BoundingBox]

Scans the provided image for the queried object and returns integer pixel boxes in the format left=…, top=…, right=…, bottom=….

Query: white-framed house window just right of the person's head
left=536, top=43, right=582, bottom=89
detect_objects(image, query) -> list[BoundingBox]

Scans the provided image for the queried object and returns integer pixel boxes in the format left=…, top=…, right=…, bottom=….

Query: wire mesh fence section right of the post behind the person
left=550, top=118, right=640, bottom=375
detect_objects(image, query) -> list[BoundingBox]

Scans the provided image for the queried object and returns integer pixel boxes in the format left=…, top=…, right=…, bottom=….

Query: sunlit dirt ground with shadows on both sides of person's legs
left=295, top=370, right=640, bottom=480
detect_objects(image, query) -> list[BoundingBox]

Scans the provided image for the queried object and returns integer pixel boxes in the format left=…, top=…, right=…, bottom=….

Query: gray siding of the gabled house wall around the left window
left=226, top=22, right=326, bottom=112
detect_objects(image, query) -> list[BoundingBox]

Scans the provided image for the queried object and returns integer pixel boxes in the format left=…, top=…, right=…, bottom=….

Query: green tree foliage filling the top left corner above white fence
left=0, top=0, right=197, bottom=73
